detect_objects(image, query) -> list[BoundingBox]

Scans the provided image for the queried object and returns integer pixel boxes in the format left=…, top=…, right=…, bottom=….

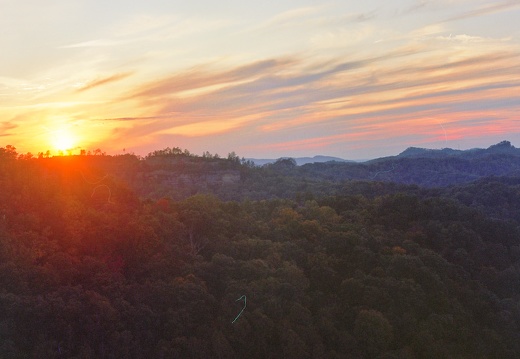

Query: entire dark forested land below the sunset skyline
left=0, top=143, right=520, bottom=359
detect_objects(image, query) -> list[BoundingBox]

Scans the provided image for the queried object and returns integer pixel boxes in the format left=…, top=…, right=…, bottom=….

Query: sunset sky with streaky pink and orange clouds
left=0, top=0, right=520, bottom=159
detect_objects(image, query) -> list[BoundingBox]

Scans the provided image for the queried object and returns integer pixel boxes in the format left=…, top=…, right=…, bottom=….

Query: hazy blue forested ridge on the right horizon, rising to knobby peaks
left=294, top=141, right=520, bottom=187
